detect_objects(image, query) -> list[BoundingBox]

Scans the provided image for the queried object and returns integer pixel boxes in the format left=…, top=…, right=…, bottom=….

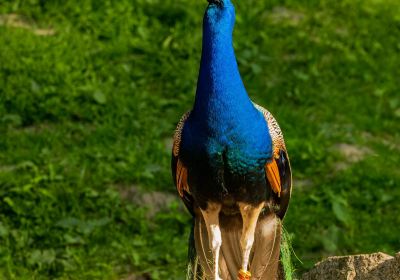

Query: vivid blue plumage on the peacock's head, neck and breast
left=182, top=1, right=272, bottom=174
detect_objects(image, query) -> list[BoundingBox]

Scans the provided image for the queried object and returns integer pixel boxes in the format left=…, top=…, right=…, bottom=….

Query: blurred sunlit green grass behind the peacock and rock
left=0, top=0, right=400, bottom=279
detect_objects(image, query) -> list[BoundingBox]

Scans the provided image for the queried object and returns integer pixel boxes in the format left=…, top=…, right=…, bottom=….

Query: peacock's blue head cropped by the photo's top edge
left=204, top=0, right=235, bottom=34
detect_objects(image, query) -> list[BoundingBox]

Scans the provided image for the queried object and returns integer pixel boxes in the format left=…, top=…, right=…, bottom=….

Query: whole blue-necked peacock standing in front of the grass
left=171, top=0, right=292, bottom=280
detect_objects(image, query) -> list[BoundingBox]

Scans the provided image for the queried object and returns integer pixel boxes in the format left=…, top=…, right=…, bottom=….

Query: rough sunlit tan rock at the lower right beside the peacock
left=301, top=252, right=400, bottom=280
